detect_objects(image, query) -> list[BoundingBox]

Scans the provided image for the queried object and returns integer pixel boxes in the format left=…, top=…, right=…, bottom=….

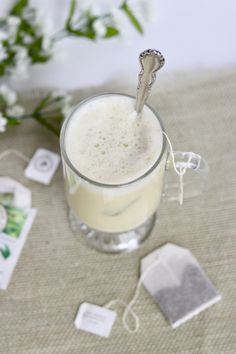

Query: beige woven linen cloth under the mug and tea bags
left=0, top=68, right=236, bottom=354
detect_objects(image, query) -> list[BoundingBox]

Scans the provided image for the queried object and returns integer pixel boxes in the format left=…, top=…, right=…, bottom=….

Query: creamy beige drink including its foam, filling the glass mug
left=64, top=94, right=166, bottom=232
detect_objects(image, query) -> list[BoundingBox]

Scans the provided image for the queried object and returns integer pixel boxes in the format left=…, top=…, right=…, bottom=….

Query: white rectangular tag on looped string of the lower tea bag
left=74, top=302, right=116, bottom=338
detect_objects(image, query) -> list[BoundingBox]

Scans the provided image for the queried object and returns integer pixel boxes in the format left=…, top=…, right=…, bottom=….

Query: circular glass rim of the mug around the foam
left=60, top=92, right=166, bottom=188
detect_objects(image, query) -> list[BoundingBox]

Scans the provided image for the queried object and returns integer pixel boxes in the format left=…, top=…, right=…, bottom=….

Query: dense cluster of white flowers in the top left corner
left=0, top=0, right=52, bottom=77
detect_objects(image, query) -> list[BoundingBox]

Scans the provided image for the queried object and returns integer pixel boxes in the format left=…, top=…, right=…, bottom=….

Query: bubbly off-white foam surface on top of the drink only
left=65, top=94, right=163, bottom=184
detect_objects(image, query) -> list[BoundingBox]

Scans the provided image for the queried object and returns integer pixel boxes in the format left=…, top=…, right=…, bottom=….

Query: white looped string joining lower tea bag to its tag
left=104, top=258, right=160, bottom=333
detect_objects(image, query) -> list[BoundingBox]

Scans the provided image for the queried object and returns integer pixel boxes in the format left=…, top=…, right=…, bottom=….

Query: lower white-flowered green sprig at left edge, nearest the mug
left=0, top=85, right=72, bottom=136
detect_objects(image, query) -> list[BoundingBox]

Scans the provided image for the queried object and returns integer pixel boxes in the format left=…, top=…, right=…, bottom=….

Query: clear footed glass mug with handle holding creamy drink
left=60, top=93, right=207, bottom=253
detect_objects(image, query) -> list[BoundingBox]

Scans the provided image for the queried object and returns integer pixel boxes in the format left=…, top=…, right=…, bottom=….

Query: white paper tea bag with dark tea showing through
left=141, top=243, right=221, bottom=328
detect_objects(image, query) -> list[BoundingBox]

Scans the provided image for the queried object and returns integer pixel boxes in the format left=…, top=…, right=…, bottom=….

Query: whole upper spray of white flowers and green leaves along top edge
left=0, top=0, right=147, bottom=78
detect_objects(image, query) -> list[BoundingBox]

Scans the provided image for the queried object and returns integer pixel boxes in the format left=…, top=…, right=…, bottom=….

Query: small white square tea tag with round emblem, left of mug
left=25, top=148, right=60, bottom=185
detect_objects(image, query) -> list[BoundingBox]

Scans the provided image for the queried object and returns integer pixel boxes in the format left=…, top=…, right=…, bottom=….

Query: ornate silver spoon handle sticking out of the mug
left=135, top=49, right=165, bottom=115
